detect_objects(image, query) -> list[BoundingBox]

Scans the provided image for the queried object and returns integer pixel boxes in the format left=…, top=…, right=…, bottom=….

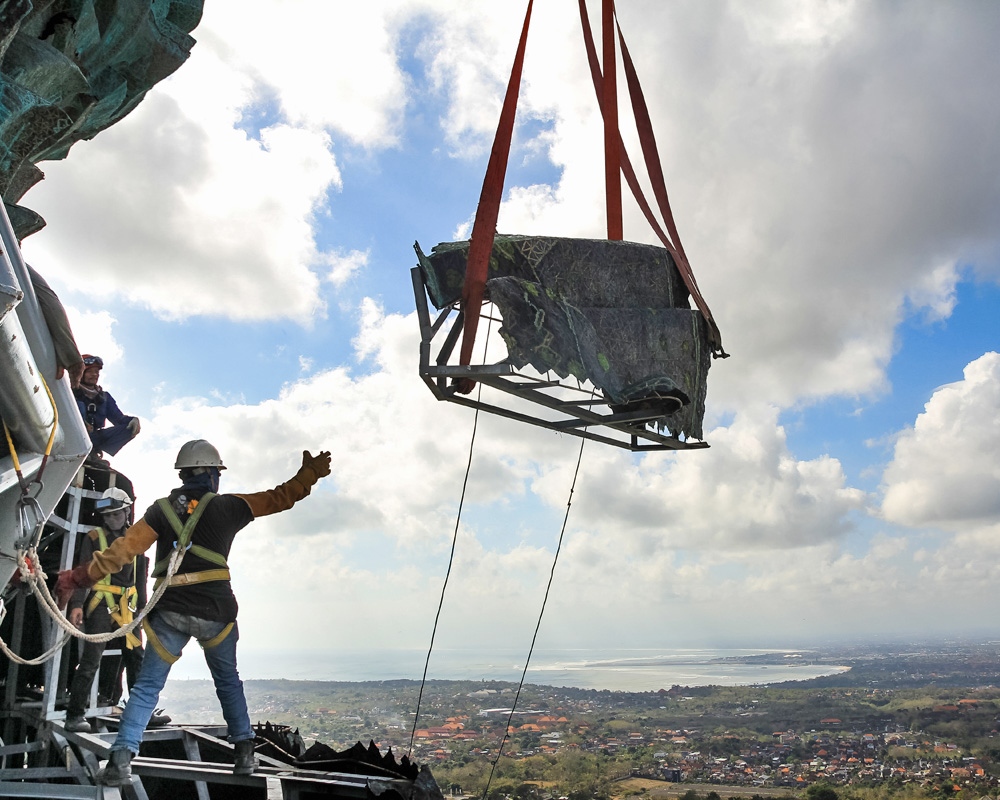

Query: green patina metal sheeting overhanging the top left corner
left=0, top=0, right=203, bottom=238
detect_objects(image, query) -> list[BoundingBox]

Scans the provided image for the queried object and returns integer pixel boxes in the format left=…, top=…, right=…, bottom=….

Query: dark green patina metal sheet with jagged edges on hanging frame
left=417, top=236, right=711, bottom=439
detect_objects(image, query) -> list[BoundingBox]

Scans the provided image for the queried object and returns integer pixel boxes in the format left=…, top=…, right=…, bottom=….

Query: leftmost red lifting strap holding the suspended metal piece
left=456, top=0, right=533, bottom=394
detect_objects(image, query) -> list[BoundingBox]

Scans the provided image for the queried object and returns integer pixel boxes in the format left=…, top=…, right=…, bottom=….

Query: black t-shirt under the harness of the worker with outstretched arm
left=145, top=489, right=253, bottom=622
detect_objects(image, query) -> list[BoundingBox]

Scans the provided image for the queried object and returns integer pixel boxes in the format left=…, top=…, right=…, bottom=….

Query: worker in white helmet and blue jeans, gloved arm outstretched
left=56, top=439, right=330, bottom=786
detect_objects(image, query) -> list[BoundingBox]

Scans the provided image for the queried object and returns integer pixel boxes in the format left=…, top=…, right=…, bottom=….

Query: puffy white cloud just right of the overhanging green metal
left=18, top=58, right=340, bottom=320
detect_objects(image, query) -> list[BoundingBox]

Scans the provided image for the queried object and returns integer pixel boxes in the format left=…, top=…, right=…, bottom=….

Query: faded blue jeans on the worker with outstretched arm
left=111, top=611, right=254, bottom=755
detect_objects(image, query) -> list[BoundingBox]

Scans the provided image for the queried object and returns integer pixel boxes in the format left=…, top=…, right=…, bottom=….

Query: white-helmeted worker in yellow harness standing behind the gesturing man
left=66, top=488, right=140, bottom=733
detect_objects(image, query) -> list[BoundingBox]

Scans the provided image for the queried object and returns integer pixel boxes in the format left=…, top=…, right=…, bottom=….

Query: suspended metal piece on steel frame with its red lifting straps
left=412, top=0, right=727, bottom=450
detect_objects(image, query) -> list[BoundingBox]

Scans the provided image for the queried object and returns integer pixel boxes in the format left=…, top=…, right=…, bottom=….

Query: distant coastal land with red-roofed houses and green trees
left=164, top=643, right=1000, bottom=800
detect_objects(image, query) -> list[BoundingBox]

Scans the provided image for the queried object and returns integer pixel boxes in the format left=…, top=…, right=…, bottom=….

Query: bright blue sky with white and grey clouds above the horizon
left=13, top=0, right=1000, bottom=678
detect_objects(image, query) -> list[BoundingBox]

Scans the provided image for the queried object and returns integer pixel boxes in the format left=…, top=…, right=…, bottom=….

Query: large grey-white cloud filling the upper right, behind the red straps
left=478, top=2, right=1000, bottom=408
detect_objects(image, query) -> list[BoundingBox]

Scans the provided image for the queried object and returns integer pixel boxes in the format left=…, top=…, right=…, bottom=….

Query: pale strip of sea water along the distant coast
left=170, top=647, right=847, bottom=692
